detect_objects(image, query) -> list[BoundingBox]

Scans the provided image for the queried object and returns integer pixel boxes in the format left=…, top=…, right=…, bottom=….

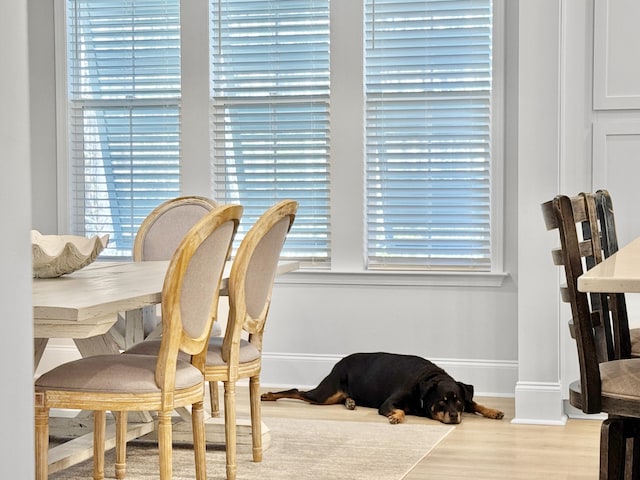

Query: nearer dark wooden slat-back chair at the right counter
left=542, top=193, right=640, bottom=480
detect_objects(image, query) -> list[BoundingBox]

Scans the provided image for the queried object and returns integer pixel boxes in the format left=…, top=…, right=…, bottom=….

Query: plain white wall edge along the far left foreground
left=0, top=0, right=34, bottom=479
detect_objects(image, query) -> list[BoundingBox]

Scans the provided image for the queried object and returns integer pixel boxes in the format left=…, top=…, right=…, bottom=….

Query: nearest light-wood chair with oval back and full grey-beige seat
left=35, top=205, right=243, bottom=480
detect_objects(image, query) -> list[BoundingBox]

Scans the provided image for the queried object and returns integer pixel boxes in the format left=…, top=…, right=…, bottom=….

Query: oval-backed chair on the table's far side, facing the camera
left=133, top=195, right=222, bottom=417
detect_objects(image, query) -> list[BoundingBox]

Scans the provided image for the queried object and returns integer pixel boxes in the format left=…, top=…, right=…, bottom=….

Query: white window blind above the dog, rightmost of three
left=365, top=0, right=492, bottom=271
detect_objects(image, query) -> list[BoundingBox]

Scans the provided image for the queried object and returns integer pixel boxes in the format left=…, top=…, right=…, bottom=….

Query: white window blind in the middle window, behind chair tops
left=211, top=0, right=330, bottom=266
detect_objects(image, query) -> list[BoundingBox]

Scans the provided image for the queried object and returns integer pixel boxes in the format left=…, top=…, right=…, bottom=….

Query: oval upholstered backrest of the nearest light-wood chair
left=156, top=204, right=243, bottom=389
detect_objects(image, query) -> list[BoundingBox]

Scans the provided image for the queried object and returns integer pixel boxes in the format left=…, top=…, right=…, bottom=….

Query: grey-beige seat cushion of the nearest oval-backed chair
left=35, top=354, right=204, bottom=393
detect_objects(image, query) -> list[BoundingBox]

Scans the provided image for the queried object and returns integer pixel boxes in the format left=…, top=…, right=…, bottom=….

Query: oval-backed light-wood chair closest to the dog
left=125, top=200, right=298, bottom=480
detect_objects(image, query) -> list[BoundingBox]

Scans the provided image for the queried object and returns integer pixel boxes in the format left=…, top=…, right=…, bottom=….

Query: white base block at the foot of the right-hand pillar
left=512, top=382, right=567, bottom=425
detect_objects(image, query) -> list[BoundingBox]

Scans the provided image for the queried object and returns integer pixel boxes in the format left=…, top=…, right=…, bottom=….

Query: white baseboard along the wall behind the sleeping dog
left=260, top=352, right=518, bottom=397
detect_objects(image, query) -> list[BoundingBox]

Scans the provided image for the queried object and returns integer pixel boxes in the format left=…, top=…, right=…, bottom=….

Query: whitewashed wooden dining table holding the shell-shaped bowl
left=32, top=261, right=299, bottom=473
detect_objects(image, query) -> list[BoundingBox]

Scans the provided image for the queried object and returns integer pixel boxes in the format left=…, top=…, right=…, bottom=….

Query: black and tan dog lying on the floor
left=261, top=352, right=504, bottom=424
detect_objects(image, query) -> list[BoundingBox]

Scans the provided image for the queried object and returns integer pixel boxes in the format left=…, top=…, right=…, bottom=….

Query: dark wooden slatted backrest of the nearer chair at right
left=542, top=193, right=628, bottom=413
